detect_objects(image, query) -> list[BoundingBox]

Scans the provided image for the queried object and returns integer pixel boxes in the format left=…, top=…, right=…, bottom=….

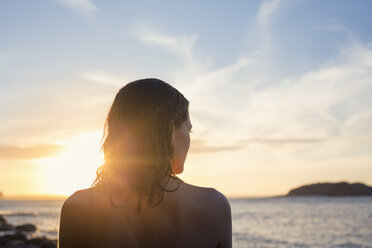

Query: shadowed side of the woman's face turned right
left=172, top=114, right=192, bottom=174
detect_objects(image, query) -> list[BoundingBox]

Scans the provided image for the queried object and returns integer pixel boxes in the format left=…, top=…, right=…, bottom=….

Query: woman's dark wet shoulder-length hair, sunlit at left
left=91, top=78, right=189, bottom=210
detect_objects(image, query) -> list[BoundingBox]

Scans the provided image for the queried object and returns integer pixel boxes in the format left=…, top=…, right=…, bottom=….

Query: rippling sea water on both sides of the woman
left=0, top=197, right=372, bottom=248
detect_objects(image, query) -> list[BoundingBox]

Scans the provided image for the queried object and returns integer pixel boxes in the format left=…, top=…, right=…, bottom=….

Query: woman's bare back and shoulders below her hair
left=59, top=178, right=232, bottom=248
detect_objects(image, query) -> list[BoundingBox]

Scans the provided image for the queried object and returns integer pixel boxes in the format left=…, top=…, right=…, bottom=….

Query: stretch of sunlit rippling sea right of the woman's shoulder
left=230, top=197, right=372, bottom=248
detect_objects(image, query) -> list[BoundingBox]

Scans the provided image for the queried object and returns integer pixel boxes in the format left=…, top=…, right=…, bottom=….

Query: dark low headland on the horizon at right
left=287, top=182, right=372, bottom=196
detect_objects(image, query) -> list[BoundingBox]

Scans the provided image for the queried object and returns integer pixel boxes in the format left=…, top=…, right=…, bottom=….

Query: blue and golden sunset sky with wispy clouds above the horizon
left=0, top=0, right=372, bottom=197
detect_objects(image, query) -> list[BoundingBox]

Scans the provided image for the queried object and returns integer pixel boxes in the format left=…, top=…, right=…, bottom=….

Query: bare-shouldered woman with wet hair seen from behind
left=58, top=78, right=232, bottom=248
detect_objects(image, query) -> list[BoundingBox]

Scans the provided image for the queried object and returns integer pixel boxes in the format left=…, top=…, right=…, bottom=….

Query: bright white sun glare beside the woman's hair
left=34, top=131, right=103, bottom=195
